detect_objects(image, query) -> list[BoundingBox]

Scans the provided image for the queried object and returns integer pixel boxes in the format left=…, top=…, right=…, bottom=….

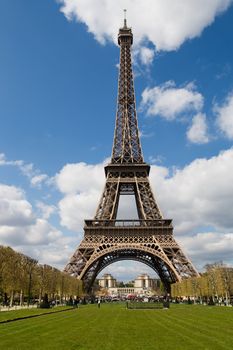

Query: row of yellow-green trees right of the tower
left=171, top=263, right=233, bottom=303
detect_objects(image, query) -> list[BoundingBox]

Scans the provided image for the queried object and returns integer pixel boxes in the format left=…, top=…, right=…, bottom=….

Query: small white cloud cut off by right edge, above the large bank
left=214, top=92, right=233, bottom=140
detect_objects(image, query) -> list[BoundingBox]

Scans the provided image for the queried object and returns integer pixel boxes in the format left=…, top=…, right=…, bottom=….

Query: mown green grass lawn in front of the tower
left=0, top=304, right=233, bottom=350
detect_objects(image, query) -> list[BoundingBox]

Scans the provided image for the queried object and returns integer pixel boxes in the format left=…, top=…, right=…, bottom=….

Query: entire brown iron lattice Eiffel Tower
left=65, top=18, right=198, bottom=293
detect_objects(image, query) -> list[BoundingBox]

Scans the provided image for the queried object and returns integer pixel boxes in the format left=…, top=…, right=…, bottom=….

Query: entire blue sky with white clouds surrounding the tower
left=0, top=0, right=233, bottom=279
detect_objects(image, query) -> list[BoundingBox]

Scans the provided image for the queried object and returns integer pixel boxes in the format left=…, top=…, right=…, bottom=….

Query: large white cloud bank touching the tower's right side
left=150, top=149, right=233, bottom=235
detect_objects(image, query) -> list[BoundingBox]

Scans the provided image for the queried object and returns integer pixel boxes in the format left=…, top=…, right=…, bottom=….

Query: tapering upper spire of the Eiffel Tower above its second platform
left=112, top=9, right=143, bottom=164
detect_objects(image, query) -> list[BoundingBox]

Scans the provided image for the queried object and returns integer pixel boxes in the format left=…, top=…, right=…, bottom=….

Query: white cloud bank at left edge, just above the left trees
left=0, top=184, right=74, bottom=268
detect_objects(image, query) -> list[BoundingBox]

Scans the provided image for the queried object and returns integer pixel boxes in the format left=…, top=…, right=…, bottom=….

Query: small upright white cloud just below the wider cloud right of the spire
left=187, top=113, right=209, bottom=144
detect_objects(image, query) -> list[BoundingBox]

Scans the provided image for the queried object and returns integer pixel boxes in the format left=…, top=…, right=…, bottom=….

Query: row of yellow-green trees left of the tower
left=0, top=246, right=82, bottom=306
